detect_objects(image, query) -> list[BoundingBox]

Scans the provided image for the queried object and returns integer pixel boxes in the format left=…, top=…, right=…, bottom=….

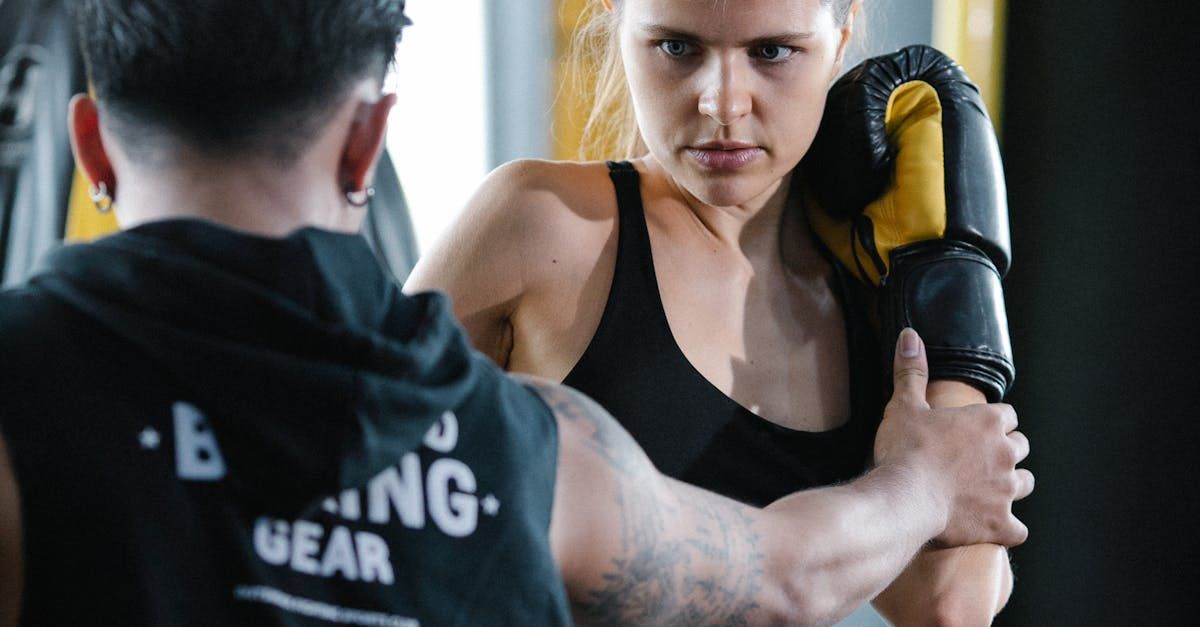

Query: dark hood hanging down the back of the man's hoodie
left=34, top=220, right=481, bottom=515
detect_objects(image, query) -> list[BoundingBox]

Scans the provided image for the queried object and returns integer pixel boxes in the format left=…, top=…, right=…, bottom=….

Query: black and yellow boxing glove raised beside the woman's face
left=799, top=46, right=1015, bottom=401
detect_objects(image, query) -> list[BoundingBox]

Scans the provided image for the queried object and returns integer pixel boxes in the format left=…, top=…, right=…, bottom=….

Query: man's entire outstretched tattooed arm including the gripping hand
left=533, top=332, right=1032, bottom=625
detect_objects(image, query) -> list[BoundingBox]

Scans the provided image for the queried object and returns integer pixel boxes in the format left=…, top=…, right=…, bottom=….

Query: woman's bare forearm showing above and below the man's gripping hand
left=872, top=381, right=1013, bottom=627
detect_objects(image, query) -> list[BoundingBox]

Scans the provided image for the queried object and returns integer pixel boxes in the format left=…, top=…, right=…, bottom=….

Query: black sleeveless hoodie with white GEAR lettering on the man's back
left=0, top=220, right=569, bottom=626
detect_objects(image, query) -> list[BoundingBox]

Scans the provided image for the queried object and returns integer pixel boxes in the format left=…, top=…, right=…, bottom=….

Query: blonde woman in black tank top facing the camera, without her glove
left=406, top=0, right=1012, bottom=625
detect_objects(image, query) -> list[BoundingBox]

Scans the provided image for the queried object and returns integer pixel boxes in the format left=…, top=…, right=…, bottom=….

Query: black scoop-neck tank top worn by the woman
left=564, top=162, right=882, bottom=506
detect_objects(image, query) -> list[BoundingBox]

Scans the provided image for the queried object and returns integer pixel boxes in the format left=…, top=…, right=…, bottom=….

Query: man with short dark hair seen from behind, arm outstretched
left=0, top=0, right=1032, bottom=626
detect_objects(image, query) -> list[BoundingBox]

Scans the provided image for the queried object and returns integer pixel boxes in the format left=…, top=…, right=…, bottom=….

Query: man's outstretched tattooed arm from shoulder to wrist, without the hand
left=539, top=377, right=944, bottom=625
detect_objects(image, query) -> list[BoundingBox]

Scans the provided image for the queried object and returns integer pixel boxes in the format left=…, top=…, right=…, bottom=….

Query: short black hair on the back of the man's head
left=72, top=0, right=407, bottom=162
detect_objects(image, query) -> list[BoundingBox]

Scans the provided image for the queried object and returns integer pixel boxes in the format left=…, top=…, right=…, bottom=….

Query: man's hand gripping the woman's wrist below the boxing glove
left=875, top=329, right=1033, bottom=547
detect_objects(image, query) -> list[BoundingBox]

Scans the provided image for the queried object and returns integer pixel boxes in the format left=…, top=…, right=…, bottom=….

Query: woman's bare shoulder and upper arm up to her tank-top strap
left=404, top=160, right=617, bottom=369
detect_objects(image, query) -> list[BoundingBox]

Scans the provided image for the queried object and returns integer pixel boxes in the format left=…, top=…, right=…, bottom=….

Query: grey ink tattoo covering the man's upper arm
left=532, top=381, right=763, bottom=625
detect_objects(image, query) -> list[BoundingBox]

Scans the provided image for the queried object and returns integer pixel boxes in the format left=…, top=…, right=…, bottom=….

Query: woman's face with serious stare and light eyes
left=619, top=0, right=848, bottom=207
